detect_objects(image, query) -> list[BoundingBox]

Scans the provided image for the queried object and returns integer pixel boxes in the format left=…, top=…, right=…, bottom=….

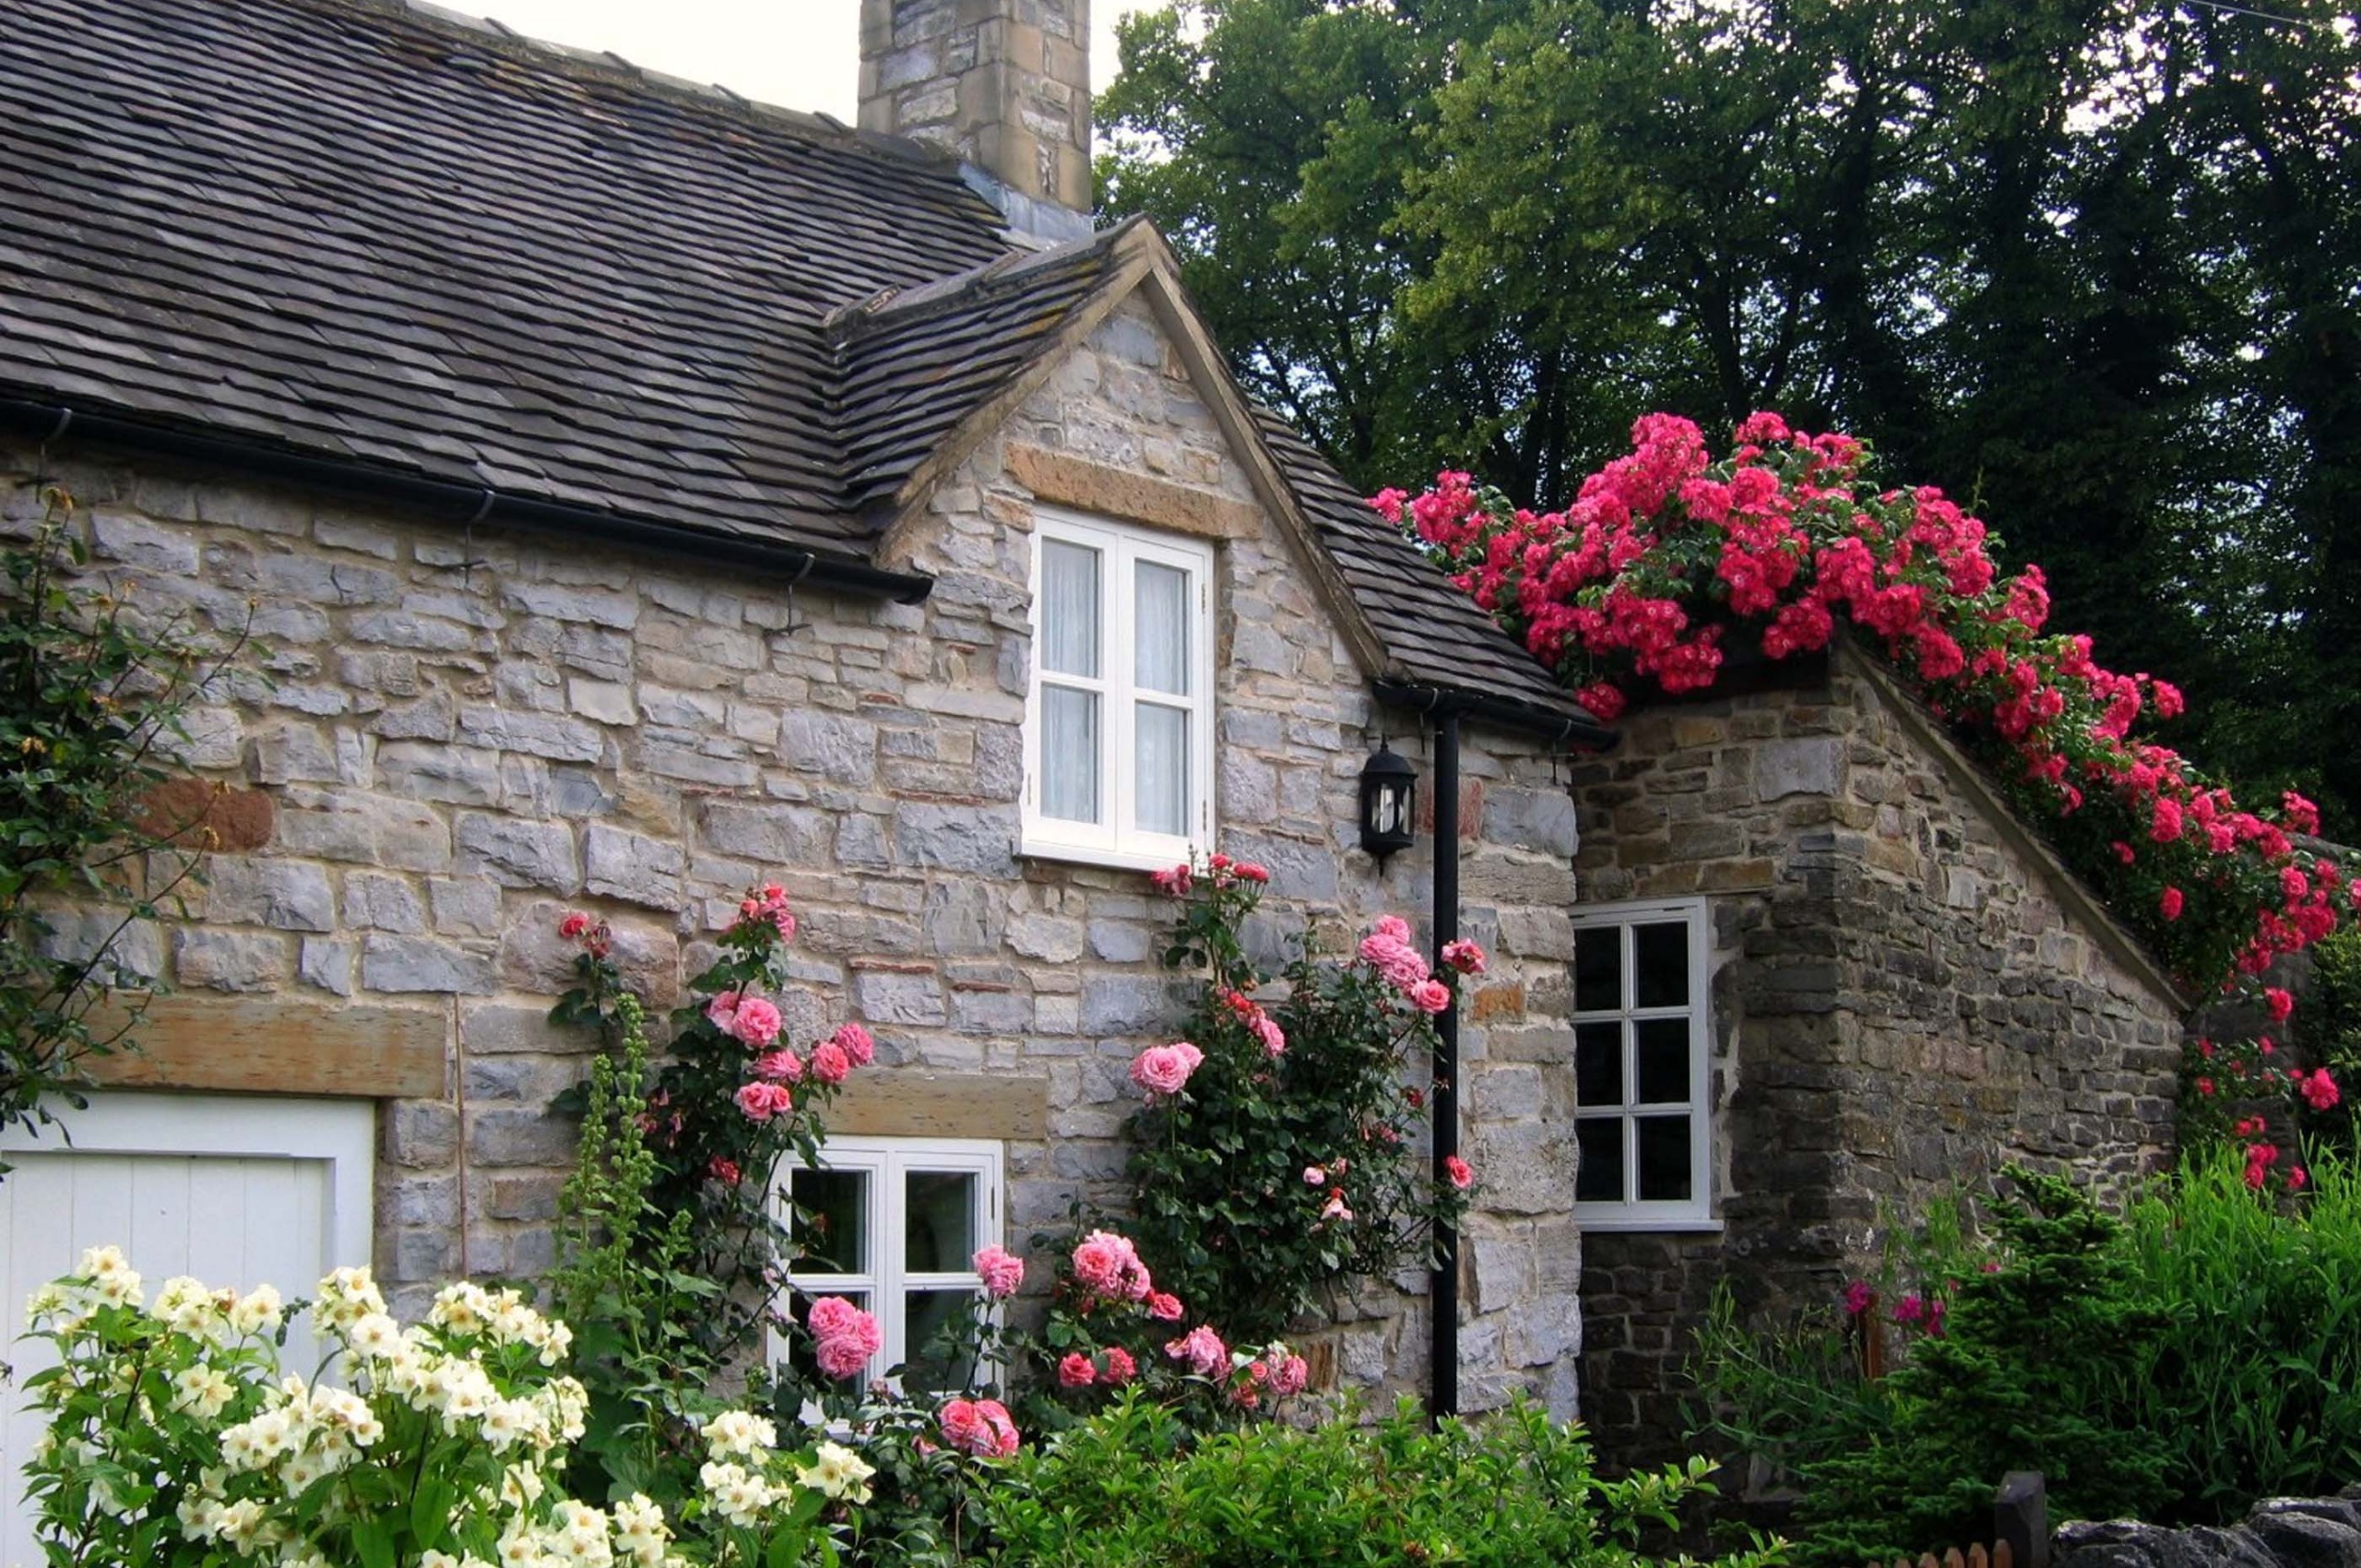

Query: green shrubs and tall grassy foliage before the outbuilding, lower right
left=1693, top=1150, right=2361, bottom=1563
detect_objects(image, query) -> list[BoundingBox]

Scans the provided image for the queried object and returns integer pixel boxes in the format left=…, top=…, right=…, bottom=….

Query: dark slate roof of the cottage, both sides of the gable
left=0, top=0, right=1605, bottom=731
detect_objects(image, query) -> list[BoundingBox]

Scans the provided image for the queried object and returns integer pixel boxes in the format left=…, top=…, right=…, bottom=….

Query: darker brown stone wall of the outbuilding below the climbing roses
left=1575, top=652, right=2179, bottom=1464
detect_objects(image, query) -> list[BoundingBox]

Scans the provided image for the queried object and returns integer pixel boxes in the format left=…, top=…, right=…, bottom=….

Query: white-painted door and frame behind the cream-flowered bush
left=0, top=1093, right=375, bottom=1563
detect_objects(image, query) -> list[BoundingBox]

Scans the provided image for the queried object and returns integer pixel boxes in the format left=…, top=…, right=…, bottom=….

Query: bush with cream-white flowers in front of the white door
left=26, top=1247, right=869, bottom=1568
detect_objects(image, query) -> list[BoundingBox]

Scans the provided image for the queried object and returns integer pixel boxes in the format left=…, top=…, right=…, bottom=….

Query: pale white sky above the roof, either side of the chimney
left=456, top=0, right=1162, bottom=125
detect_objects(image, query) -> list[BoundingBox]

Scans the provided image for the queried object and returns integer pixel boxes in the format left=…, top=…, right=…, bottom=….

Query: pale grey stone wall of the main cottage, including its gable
left=0, top=290, right=1580, bottom=1408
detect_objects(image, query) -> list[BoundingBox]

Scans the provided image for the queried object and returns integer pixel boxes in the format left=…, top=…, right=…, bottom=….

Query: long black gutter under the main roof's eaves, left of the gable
left=0, top=399, right=935, bottom=604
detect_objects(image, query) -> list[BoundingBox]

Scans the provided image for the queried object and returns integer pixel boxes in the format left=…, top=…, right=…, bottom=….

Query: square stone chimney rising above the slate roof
left=861, top=0, right=1091, bottom=232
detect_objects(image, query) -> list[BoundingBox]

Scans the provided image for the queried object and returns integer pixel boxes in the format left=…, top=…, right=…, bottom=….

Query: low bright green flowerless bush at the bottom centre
left=985, top=1398, right=1780, bottom=1568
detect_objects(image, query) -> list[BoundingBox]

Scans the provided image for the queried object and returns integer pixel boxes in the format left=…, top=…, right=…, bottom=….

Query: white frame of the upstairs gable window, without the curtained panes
left=1017, top=507, right=1214, bottom=872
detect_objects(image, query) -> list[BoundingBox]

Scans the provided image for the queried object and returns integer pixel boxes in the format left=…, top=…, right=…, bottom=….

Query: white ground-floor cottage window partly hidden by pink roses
left=772, top=1138, right=1001, bottom=1394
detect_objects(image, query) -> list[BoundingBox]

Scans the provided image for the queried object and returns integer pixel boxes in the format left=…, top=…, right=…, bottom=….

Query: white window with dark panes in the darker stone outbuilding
left=1575, top=899, right=1714, bottom=1230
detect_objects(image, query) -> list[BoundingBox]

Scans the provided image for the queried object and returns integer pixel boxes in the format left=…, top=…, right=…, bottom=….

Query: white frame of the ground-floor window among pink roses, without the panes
left=770, top=1135, right=1006, bottom=1388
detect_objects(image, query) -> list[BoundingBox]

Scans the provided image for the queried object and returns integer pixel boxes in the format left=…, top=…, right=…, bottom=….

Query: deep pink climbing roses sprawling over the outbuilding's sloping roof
left=1371, top=413, right=2361, bottom=1190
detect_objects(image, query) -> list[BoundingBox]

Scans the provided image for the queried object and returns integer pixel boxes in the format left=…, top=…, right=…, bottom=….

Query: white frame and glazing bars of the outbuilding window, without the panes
left=1568, top=897, right=1721, bottom=1232
